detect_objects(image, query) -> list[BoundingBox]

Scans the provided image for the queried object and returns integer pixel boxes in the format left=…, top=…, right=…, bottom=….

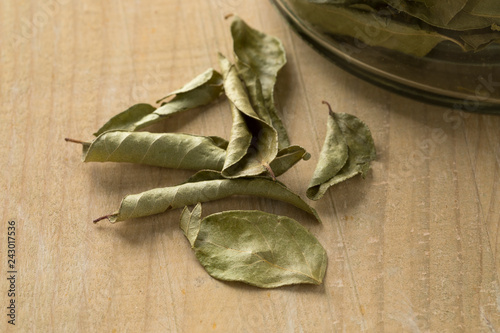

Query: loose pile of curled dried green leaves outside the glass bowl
left=66, top=17, right=375, bottom=288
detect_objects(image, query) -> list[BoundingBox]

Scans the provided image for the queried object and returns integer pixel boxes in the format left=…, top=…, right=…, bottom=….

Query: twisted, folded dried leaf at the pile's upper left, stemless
left=94, top=68, right=222, bottom=136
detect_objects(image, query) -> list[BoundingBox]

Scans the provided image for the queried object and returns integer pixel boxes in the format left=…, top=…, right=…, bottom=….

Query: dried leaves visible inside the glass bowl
left=300, top=0, right=500, bottom=57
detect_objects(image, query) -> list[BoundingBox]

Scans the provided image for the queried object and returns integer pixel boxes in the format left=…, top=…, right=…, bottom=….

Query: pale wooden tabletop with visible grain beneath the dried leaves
left=0, top=0, right=500, bottom=332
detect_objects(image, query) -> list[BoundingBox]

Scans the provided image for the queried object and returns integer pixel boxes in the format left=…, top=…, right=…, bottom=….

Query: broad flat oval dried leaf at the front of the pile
left=181, top=206, right=327, bottom=288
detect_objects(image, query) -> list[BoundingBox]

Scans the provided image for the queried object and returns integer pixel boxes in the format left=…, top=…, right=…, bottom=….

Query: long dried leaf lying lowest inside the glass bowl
left=290, top=0, right=462, bottom=57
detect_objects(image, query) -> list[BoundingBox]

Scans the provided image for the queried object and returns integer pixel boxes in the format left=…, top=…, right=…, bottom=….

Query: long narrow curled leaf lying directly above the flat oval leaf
left=95, top=171, right=320, bottom=223
